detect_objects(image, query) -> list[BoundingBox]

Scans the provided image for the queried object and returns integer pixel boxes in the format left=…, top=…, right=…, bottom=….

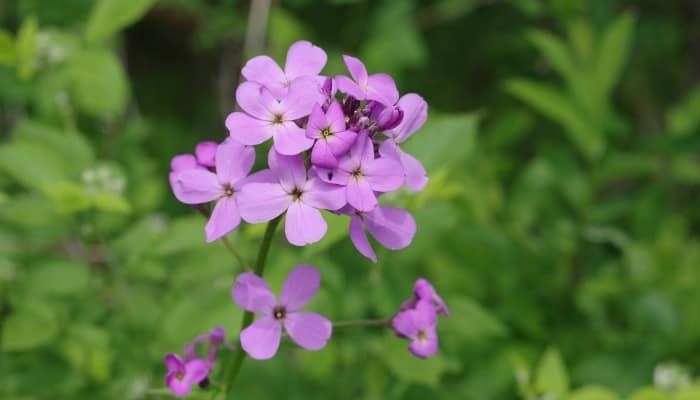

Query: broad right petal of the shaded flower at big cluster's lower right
left=365, top=206, right=416, bottom=250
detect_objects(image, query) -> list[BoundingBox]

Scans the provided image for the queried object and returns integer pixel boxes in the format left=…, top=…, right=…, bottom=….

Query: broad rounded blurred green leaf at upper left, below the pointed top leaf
left=67, top=50, right=129, bottom=118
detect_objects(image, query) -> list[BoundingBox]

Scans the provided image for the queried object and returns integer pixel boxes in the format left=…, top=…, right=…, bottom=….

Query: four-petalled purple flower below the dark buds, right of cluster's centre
left=318, top=132, right=404, bottom=212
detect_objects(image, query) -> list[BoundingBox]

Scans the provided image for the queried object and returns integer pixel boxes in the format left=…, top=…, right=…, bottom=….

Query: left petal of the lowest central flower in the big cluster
left=238, top=182, right=292, bottom=224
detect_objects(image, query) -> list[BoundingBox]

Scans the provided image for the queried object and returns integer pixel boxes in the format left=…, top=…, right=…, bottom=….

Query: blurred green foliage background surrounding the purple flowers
left=0, top=0, right=700, bottom=400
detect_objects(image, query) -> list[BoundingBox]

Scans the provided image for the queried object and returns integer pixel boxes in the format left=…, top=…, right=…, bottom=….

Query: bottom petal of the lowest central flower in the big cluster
left=284, top=201, right=328, bottom=246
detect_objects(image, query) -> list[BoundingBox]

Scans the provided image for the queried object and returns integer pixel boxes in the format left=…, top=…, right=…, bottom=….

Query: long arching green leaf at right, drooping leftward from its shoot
left=505, top=79, right=605, bottom=160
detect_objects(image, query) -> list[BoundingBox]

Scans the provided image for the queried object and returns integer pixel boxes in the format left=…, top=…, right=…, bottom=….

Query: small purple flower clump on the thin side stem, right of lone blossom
left=391, top=278, right=448, bottom=358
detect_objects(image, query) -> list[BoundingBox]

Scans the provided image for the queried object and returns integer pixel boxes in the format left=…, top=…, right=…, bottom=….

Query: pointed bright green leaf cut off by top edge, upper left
left=85, top=0, right=156, bottom=43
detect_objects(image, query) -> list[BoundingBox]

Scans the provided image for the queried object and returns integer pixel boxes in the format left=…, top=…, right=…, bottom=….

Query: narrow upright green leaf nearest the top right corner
left=596, top=13, right=635, bottom=96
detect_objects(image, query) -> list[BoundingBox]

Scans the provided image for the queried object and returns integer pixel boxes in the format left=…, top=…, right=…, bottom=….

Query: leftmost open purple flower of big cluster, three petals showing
left=173, top=140, right=255, bottom=242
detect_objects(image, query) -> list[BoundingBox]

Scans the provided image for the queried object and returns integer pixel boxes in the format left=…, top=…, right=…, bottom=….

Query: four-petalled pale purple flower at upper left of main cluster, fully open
left=226, top=78, right=324, bottom=155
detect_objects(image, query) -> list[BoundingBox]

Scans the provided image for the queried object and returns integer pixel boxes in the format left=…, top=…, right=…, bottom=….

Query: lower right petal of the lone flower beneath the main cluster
left=284, top=312, right=333, bottom=351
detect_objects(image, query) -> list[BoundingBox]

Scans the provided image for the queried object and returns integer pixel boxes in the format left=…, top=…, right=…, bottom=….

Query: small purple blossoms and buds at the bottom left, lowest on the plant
left=164, top=327, right=225, bottom=397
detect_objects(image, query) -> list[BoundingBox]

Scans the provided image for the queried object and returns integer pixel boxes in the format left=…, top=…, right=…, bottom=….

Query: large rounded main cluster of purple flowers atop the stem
left=170, top=41, right=428, bottom=261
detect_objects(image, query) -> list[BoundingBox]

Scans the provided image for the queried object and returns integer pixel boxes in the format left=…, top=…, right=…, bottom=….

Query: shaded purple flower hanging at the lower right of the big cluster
left=350, top=205, right=416, bottom=262
